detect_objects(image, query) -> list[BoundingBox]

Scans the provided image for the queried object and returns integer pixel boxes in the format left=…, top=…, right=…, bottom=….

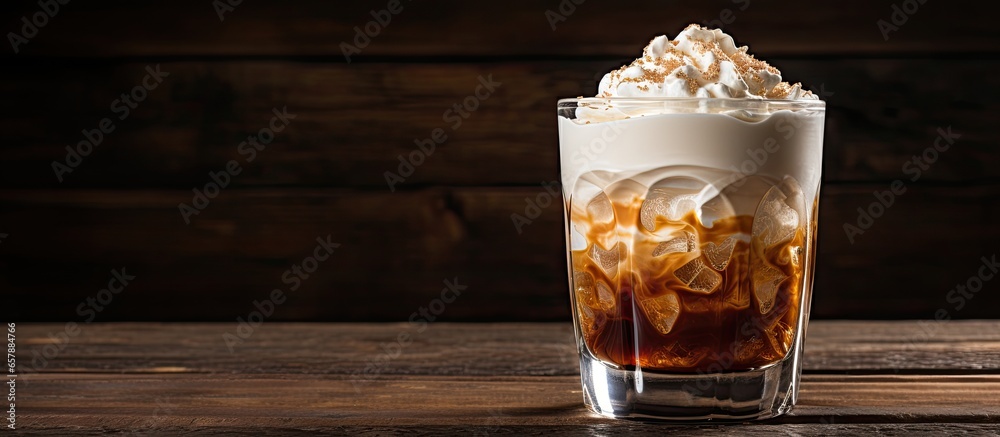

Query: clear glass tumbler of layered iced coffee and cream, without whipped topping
left=558, top=98, right=825, bottom=421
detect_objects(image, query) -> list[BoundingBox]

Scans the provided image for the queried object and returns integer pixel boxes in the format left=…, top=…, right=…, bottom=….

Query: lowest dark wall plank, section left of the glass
left=0, top=188, right=569, bottom=321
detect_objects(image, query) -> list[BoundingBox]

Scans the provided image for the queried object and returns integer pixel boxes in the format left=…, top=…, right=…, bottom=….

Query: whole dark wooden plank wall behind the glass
left=0, top=0, right=1000, bottom=321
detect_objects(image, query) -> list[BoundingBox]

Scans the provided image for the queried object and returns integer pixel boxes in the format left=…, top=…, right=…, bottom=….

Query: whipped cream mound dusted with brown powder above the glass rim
left=597, top=24, right=817, bottom=100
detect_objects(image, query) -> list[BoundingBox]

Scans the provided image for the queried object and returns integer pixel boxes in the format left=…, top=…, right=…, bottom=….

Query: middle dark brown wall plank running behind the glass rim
left=0, top=59, right=1000, bottom=187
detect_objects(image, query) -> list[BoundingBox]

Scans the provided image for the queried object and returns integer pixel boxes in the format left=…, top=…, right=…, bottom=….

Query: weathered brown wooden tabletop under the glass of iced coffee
left=4, top=321, right=1000, bottom=436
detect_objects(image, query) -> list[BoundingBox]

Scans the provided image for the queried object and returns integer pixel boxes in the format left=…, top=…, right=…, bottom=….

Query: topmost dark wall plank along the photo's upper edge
left=0, top=0, right=1000, bottom=60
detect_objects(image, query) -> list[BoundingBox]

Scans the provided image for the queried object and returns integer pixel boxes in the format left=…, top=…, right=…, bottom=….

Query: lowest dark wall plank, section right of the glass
left=813, top=184, right=1000, bottom=319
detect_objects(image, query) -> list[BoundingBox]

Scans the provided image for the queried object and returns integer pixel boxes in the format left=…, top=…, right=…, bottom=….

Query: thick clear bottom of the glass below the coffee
left=580, top=334, right=802, bottom=422
